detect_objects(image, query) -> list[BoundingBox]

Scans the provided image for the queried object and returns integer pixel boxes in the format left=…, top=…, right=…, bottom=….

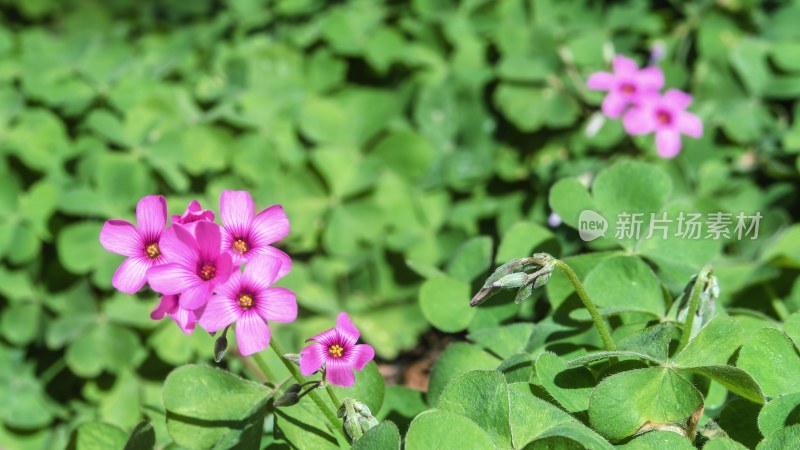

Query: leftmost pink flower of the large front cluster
left=100, top=195, right=167, bottom=294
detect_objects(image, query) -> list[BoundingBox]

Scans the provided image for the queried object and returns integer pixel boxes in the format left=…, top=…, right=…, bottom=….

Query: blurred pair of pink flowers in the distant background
left=586, top=56, right=703, bottom=158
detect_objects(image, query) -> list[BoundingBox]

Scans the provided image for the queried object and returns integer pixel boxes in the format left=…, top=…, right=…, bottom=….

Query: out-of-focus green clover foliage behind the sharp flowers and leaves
left=0, top=0, right=800, bottom=449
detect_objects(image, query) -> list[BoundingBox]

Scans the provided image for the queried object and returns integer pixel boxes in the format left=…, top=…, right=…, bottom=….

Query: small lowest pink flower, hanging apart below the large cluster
left=300, top=313, right=375, bottom=387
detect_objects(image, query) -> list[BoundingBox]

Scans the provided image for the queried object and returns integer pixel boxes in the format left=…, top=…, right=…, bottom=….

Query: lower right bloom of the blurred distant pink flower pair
left=622, top=89, right=703, bottom=158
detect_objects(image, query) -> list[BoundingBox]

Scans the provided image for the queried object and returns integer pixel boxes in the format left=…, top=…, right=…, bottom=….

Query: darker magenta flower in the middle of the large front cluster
left=147, top=221, right=234, bottom=311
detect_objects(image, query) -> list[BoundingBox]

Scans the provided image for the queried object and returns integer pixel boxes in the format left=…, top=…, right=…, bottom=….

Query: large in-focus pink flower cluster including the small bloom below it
left=100, top=191, right=375, bottom=386
